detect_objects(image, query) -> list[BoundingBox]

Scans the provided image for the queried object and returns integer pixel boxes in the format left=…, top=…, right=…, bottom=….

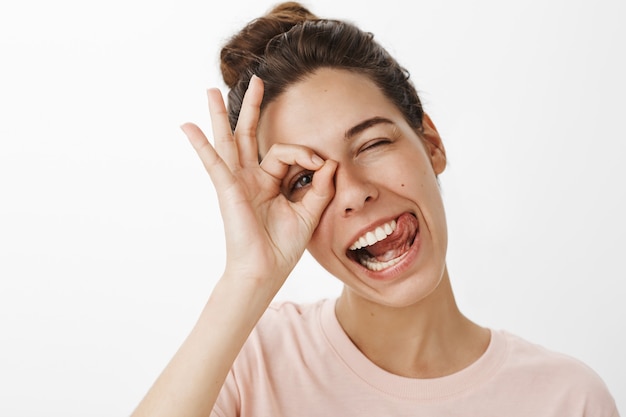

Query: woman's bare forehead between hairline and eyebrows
left=257, top=68, right=404, bottom=156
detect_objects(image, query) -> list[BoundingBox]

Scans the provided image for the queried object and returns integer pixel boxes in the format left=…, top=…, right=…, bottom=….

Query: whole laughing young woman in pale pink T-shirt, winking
left=130, top=3, right=618, bottom=417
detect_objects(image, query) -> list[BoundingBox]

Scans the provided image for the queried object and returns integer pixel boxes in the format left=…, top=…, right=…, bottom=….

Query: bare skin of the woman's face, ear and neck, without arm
left=257, top=69, right=489, bottom=378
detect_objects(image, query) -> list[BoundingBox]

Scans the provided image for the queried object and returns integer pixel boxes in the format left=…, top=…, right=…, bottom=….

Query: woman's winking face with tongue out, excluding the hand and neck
left=258, top=69, right=447, bottom=307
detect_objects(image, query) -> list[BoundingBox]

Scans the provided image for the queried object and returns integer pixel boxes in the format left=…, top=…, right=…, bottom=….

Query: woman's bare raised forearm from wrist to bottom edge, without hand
left=133, top=277, right=273, bottom=417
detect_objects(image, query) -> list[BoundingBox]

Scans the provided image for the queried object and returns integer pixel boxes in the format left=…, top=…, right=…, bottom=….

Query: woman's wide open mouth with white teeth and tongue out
left=347, top=213, right=419, bottom=272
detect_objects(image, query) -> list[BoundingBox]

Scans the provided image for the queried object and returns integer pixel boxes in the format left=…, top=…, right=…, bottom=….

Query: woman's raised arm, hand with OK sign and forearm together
left=138, top=77, right=337, bottom=417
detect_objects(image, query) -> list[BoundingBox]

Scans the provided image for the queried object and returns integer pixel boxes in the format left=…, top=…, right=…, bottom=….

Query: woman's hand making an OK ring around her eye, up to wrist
left=182, top=76, right=336, bottom=297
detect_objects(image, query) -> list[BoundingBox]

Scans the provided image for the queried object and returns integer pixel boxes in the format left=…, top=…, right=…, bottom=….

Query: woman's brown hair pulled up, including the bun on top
left=221, top=2, right=423, bottom=131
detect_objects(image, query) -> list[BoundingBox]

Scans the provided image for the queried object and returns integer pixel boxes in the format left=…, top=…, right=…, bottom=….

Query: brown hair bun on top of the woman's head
left=220, top=2, right=317, bottom=88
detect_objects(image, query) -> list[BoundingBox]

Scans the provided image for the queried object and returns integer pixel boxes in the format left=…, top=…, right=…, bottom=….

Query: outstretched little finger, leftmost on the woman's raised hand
left=181, top=123, right=235, bottom=190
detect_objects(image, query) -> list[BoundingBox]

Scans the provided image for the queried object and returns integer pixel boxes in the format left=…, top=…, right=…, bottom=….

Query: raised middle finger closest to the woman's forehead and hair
left=235, top=75, right=264, bottom=166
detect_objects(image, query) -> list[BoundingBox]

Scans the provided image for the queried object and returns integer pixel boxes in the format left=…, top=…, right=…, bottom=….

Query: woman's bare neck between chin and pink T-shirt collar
left=336, top=270, right=490, bottom=378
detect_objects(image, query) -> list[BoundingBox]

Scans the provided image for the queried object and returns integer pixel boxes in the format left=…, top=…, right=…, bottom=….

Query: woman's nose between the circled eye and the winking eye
left=335, top=164, right=378, bottom=216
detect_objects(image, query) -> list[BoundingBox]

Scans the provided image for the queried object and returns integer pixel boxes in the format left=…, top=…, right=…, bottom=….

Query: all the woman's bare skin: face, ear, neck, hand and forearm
left=133, top=69, right=489, bottom=416
